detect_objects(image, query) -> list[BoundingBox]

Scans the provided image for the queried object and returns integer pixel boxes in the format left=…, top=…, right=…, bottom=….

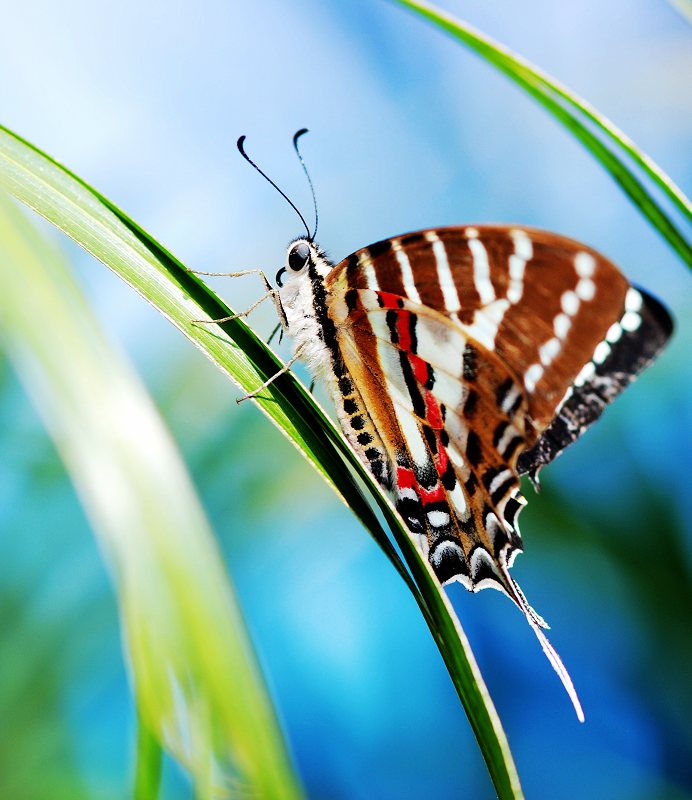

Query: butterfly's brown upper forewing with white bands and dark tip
left=328, top=225, right=672, bottom=477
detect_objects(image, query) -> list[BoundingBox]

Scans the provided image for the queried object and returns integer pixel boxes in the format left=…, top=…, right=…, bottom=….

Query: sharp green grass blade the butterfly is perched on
left=0, top=128, right=522, bottom=800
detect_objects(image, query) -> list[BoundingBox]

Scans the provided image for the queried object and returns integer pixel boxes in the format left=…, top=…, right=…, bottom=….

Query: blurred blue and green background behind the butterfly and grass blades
left=0, top=0, right=692, bottom=800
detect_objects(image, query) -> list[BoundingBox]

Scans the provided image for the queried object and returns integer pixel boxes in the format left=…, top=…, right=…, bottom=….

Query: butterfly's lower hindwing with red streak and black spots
left=337, top=289, right=523, bottom=590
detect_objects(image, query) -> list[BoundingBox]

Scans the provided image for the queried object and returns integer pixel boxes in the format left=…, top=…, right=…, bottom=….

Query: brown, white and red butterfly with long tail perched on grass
left=239, top=131, right=672, bottom=719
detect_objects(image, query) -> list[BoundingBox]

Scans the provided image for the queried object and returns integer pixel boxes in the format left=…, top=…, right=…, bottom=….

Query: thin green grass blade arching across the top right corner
left=395, top=0, right=692, bottom=267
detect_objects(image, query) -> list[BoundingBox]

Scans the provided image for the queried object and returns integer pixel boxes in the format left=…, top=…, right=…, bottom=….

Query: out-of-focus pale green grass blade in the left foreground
left=0, top=192, right=301, bottom=800
